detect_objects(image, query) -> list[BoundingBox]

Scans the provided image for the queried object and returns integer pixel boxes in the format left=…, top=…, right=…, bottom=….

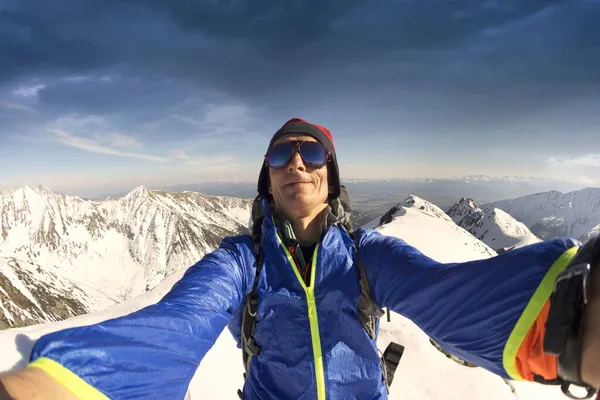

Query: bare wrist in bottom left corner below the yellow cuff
left=0, top=368, right=77, bottom=400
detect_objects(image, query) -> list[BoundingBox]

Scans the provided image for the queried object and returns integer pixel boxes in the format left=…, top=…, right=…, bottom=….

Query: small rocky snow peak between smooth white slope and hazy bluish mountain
left=447, top=197, right=540, bottom=253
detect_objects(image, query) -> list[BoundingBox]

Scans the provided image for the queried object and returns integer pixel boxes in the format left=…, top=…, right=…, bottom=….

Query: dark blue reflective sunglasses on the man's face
left=265, top=142, right=330, bottom=168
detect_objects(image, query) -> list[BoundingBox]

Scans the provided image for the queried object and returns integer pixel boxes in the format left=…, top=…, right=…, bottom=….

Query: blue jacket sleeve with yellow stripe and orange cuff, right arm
left=359, top=230, right=579, bottom=383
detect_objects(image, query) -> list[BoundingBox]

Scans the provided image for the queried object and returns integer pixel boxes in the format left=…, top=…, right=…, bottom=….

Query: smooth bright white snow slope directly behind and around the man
left=0, top=197, right=566, bottom=400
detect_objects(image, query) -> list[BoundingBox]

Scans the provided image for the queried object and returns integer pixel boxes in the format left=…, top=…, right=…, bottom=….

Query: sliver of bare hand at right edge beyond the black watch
left=581, top=262, right=600, bottom=389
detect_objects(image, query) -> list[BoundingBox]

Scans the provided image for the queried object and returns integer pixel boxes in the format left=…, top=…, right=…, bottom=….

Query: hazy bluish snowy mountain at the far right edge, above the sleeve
left=481, top=188, right=600, bottom=240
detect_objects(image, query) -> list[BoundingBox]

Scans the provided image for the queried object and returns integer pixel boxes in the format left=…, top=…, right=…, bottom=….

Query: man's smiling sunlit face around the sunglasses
left=269, top=136, right=329, bottom=218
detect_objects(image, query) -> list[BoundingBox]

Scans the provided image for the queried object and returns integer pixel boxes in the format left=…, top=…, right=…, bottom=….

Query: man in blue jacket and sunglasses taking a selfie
left=2, top=119, right=600, bottom=400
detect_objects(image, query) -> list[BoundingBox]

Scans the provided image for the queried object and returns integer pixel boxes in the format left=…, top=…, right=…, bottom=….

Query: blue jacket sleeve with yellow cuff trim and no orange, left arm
left=29, top=237, right=251, bottom=399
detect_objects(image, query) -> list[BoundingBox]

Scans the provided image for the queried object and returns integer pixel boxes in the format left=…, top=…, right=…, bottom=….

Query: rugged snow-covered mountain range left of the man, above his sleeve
left=0, top=186, right=251, bottom=327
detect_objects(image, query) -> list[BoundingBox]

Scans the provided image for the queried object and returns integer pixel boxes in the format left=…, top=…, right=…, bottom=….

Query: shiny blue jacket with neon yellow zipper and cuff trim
left=30, top=202, right=577, bottom=400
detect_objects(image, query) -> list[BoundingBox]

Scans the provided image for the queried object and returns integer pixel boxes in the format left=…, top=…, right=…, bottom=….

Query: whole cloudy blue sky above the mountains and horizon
left=0, top=0, right=600, bottom=196
